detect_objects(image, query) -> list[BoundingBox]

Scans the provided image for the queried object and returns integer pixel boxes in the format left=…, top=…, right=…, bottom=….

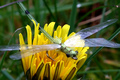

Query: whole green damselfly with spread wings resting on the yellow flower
left=0, top=0, right=120, bottom=60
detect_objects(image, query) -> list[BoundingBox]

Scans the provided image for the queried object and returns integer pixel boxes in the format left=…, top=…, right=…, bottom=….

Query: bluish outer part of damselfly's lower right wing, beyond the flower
left=85, top=38, right=120, bottom=48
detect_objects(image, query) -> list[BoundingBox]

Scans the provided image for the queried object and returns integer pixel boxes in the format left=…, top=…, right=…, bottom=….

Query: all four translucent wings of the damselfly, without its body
left=0, top=19, right=120, bottom=60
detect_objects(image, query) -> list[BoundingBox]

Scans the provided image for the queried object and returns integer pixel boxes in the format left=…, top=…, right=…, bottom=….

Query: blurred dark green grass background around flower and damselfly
left=0, top=0, right=120, bottom=80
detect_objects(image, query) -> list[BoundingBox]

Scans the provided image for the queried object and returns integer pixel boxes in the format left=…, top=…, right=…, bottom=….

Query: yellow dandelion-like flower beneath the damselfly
left=19, top=21, right=89, bottom=80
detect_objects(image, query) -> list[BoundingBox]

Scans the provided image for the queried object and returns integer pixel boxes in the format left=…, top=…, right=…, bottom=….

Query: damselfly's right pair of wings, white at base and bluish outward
left=65, top=19, right=120, bottom=48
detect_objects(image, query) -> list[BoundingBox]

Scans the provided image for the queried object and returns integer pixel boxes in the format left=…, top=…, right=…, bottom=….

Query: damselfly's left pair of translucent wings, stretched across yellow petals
left=0, top=44, right=61, bottom=60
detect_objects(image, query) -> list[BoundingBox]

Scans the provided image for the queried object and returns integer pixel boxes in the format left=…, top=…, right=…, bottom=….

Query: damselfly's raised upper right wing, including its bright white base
left=64, top=19, right=117, bottom=47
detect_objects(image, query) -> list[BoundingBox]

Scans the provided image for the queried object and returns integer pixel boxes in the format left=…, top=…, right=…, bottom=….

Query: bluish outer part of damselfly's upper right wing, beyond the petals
left=75, top=19, right=117, bottom=39
